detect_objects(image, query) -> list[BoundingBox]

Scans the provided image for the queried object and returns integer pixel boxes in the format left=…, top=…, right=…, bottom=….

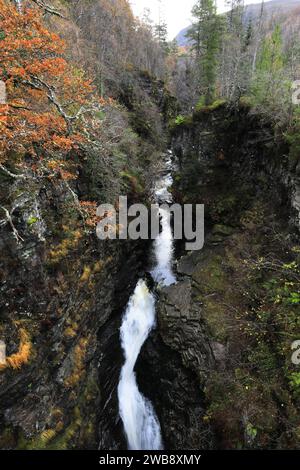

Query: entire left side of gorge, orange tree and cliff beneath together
left=0, top=0, right=176, bottom=449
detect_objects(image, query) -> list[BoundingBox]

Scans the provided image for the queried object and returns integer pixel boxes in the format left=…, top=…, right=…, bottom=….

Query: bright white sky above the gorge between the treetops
left=130, top=0, right=261, bottom=39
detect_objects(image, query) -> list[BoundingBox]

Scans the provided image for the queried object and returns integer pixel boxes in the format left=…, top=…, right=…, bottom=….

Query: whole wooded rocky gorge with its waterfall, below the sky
left=0, top=0, right=300, bottom=452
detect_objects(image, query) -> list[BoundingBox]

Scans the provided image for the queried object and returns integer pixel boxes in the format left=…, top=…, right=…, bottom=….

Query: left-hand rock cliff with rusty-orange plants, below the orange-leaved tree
left=0, top=165, right=150, bottom=449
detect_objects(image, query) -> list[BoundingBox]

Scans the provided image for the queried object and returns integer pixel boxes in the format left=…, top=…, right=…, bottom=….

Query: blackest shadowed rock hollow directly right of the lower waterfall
left=137, top=326, right=214, bottom=450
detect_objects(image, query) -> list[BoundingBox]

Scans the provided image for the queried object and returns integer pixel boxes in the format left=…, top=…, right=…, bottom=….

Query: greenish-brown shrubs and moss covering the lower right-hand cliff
left=193, top=194, right=300, bottom=449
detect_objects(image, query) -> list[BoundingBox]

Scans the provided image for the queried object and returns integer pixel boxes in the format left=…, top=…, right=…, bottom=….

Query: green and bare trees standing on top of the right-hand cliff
left=172, top=0, right=300, bottom=169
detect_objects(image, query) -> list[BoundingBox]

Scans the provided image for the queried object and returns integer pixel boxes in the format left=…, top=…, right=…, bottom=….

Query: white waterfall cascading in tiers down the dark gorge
left=118, top=154, right=176, bottom=450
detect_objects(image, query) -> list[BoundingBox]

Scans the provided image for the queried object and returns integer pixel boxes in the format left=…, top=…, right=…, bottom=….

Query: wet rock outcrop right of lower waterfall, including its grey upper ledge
left=137, top=255, right=215, bottom=449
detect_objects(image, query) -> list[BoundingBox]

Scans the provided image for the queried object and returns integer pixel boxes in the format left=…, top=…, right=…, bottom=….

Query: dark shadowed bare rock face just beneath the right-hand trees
left=173, top=103, right=300, bottom=230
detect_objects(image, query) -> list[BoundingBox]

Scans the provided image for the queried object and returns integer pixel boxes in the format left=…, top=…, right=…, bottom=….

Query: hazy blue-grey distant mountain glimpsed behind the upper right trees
left=176, top=0, right=300, bottom=46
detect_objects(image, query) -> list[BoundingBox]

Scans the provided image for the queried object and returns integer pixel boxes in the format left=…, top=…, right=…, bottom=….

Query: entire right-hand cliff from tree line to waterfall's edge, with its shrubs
left=138, top=106, right=300, bottom=449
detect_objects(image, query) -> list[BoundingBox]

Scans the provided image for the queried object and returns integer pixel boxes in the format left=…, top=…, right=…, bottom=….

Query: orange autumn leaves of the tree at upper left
left=0, top=0, right=95, bottom=179
